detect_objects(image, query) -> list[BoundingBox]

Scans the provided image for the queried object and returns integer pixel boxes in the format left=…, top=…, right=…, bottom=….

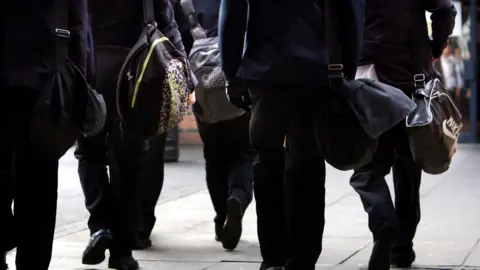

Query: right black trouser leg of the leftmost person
left=11, top=89, right=58, bottom=270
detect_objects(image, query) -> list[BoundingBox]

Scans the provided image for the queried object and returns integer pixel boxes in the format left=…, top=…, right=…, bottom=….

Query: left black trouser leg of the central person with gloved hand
left=250, top=86, right=289, bottom=266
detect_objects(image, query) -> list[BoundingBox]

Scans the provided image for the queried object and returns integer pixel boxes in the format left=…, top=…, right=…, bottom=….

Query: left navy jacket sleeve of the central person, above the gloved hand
left=218, top=0, right=248, bottom=81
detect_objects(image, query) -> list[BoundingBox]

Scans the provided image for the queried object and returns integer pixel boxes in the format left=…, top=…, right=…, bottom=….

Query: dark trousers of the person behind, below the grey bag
left=197, top=113, right=255, bottom=224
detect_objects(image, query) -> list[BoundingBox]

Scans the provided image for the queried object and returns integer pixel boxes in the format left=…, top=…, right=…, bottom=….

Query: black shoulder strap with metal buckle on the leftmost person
left=55, top=0, right=70, bottom=69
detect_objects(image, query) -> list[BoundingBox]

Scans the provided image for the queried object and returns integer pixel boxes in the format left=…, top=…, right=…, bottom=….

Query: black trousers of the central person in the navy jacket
left=250, top=85, right=325, bottom=270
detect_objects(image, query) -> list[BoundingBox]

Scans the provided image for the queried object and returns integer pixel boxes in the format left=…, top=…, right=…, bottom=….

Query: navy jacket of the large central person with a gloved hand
left=219, top=0, right=364, bottom=86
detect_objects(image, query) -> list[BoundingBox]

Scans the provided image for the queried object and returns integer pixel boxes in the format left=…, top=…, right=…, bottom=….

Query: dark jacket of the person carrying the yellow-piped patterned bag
left=89, top=0, right=185, bottom=52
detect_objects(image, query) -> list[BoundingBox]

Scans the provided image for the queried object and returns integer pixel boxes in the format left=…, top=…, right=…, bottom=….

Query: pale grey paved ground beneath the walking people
left=4, top=145, right=480, bottom=270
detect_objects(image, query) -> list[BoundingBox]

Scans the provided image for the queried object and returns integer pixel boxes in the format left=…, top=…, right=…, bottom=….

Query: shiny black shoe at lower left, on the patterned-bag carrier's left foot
left=82, top=230, right=112, bottom=265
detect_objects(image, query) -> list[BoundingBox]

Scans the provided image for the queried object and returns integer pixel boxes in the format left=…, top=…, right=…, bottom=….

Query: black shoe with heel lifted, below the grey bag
left=221, top=197, right=243, bottom=250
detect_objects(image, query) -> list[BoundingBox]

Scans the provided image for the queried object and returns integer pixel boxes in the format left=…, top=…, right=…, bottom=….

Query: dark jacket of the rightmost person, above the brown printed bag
left=360, top=0, right=456, bottom=90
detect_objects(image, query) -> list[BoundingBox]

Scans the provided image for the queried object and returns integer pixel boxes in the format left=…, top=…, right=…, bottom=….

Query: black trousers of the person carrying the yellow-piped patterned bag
left=75, top=122, right=151, bottom=256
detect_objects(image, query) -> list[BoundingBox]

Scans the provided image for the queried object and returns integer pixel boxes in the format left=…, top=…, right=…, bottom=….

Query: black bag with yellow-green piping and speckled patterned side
left=115, top=0, right=193, bottom=140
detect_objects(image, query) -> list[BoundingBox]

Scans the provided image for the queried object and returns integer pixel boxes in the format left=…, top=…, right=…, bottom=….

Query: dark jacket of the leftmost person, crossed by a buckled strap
left=0, top=0, right=88, bottom=90
